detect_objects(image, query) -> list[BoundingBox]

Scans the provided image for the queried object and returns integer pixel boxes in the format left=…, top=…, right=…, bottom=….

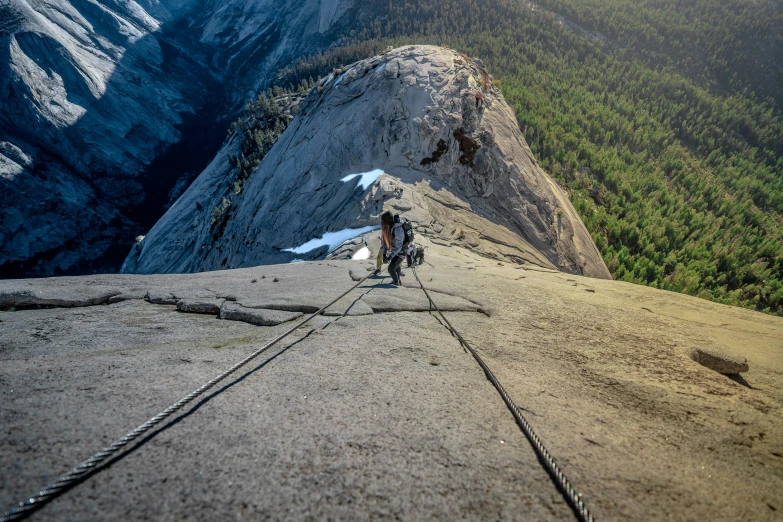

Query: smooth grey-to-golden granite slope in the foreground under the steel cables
left=0, top=244, right=783, bottom=520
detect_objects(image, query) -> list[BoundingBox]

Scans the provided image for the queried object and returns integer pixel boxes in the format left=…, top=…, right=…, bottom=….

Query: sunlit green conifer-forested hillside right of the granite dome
left=279, top=0, right=783, bottom=314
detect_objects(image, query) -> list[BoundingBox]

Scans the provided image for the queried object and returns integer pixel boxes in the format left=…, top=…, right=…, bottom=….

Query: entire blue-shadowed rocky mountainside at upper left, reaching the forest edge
left=0, top=0, right=357, bottom=277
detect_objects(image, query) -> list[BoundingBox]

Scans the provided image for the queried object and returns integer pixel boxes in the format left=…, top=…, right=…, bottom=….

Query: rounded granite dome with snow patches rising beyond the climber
left=123, top=46, right=610, bottom=278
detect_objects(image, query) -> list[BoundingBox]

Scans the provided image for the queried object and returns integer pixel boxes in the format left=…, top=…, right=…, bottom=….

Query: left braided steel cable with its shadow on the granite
left=0, top=268, right=381, bottom=522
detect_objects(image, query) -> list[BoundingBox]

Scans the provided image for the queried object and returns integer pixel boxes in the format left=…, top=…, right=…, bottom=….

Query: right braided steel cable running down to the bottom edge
left=413, top=266, right=594, bottom=522
